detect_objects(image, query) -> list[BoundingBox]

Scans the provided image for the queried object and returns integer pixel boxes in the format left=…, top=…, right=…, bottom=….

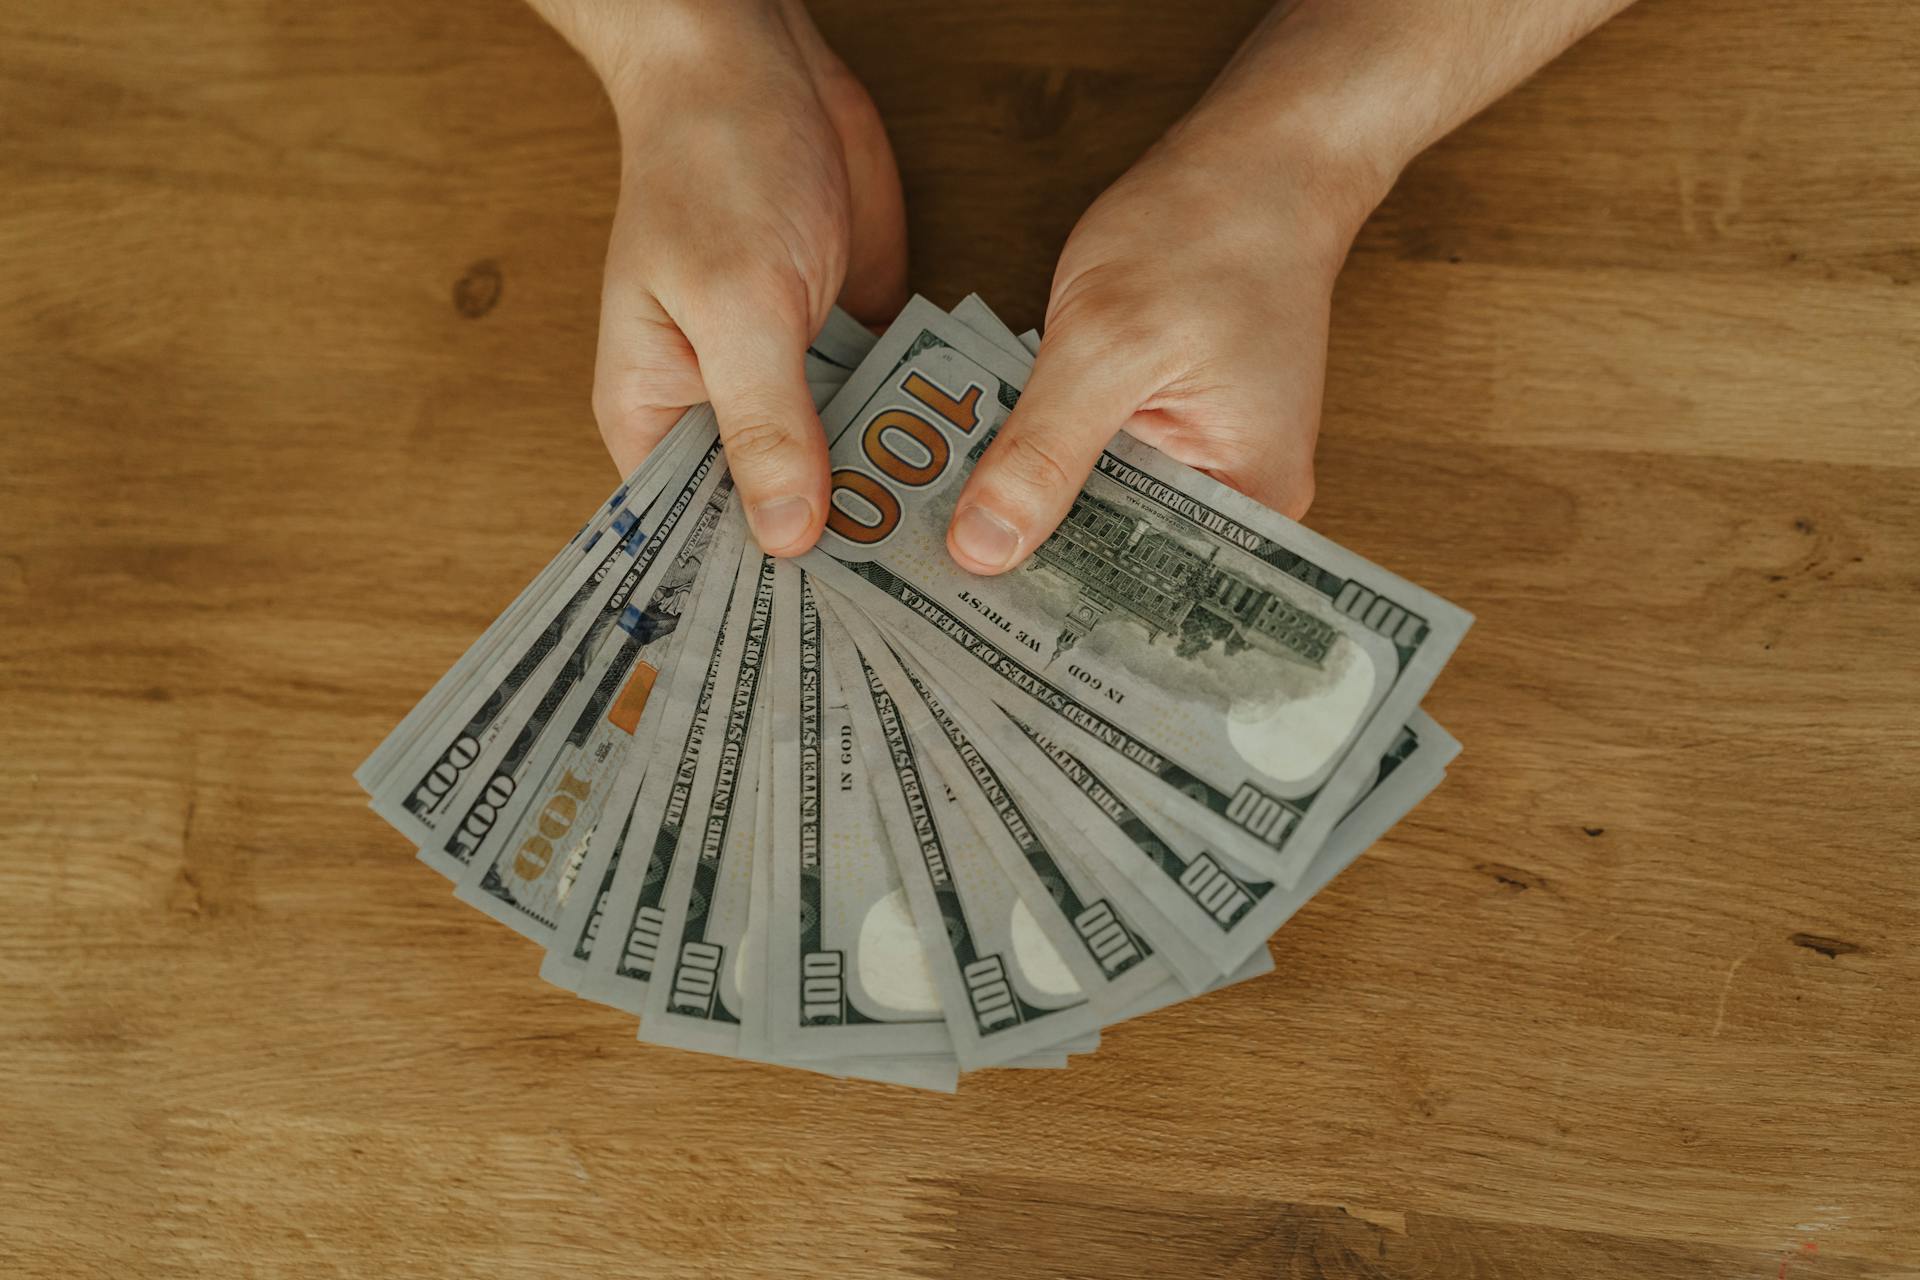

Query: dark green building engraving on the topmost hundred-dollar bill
left=1031, top=493, right=1334, bottom=666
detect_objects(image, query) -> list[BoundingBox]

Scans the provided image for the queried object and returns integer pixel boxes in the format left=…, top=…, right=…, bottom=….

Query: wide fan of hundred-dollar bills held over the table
left=357, top=297, right=1471, bottom=1090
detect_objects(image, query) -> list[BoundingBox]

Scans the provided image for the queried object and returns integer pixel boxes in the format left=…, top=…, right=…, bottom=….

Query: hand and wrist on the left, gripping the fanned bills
left=534, top=0, right=906, bottom=555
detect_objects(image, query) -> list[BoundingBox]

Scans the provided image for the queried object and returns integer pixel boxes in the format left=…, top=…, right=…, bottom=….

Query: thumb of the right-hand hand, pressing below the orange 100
left=947, top=326, right=1156, bottom=574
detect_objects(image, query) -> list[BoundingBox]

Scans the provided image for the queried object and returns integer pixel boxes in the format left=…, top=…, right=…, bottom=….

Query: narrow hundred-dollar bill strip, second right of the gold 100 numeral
left=580, top=503, right=772, bottom=1013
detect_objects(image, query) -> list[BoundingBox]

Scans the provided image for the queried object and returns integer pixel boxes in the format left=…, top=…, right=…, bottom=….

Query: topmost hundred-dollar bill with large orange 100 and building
left=803, top=299, right=1471, bottom=883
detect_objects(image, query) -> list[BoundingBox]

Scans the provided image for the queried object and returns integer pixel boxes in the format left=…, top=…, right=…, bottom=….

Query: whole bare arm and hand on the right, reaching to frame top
left=948, top=0, right=1630, bottom=574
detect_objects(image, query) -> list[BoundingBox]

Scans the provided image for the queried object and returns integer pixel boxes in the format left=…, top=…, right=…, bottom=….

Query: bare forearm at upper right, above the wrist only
left=1187, top=0, right=1632, bottom=217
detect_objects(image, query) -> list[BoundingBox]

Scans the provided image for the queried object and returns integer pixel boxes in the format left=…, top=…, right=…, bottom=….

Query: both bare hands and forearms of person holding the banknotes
left=532, top=0, right=1630, bottom=574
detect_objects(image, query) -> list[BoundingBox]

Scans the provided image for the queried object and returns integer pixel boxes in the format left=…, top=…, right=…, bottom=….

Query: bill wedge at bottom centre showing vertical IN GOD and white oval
left=766, top=560, right=952, bottom=1059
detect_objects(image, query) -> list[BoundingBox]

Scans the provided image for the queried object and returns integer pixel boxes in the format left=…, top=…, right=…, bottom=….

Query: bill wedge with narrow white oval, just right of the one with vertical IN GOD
left=826, top=602, right=1098, bottom=1071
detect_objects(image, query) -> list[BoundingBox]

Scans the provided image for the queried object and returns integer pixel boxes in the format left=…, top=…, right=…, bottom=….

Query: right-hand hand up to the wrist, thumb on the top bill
left=947, top=111, right=1384, bottom=574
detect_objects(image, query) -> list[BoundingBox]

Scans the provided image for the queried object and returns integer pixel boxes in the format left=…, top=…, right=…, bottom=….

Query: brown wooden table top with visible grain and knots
left=0, top=0, right=1920, bottom=1280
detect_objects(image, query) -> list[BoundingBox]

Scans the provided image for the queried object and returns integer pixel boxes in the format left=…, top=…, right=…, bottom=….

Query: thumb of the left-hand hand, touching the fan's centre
left=687, top=315, right=828, bottom=557
